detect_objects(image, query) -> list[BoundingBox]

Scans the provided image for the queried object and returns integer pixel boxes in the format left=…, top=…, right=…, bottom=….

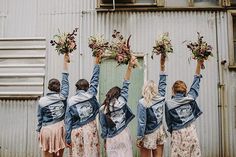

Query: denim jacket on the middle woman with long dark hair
left=99, top=80, right=134, bottom=139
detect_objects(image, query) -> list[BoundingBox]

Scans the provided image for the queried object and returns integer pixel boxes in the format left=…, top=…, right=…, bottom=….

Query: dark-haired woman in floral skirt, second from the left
left=65, top=55, right=100, bottom=157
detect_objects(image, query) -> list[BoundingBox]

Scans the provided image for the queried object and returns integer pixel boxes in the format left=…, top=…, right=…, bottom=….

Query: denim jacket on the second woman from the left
left=65, top=64, right=100, bottom=144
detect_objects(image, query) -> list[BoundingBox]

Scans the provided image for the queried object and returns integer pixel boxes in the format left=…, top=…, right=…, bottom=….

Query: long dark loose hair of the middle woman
left=103, top=86, right=121, bottom=128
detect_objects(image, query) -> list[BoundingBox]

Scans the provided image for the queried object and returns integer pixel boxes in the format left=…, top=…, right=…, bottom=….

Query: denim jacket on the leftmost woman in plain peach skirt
left=36, top=73, right=69, bottom=132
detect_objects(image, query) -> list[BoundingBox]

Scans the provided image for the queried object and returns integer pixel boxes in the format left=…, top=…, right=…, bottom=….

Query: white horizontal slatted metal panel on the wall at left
left=0, top=38, right=46, bottom=97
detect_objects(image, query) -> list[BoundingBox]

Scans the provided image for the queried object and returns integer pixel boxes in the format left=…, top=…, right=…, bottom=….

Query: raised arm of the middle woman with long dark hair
left=120, top=56, right=137, bottom=101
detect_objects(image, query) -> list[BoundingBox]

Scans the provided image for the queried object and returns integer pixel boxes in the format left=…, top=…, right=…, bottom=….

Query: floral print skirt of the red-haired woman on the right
left=171, top=124, right=201, bottom=157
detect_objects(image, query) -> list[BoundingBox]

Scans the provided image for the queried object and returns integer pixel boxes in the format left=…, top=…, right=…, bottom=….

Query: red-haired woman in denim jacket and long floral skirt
left=165, top=60, right=203, bottom=157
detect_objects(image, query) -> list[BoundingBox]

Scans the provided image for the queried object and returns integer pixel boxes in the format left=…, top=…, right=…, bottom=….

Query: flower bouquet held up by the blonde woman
left=151, top=32, right=173, bottom=59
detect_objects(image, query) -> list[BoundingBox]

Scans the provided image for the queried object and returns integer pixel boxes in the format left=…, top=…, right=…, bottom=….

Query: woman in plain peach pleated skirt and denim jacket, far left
left=37, top=54, right=69, bottom=157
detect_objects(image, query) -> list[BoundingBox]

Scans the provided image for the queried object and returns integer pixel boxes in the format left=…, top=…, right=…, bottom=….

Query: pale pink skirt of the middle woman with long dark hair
left=106, top=128, right=133, bottom=157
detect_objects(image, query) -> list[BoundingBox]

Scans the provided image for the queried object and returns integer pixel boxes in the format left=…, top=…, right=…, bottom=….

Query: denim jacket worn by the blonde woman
left=137, top=74, right=166, bottom=139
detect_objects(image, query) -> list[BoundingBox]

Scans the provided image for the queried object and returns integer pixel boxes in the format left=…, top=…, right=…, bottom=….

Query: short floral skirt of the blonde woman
left=143, top=125, right=167, bottom=149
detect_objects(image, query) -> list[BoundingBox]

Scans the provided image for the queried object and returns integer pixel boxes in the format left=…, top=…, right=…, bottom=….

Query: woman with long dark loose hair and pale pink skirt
left=99, top=56, right=136, bottom=157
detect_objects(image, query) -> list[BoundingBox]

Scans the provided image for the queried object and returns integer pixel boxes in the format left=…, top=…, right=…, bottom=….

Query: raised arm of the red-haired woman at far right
left=188, top=60, right=203, bottom=100
